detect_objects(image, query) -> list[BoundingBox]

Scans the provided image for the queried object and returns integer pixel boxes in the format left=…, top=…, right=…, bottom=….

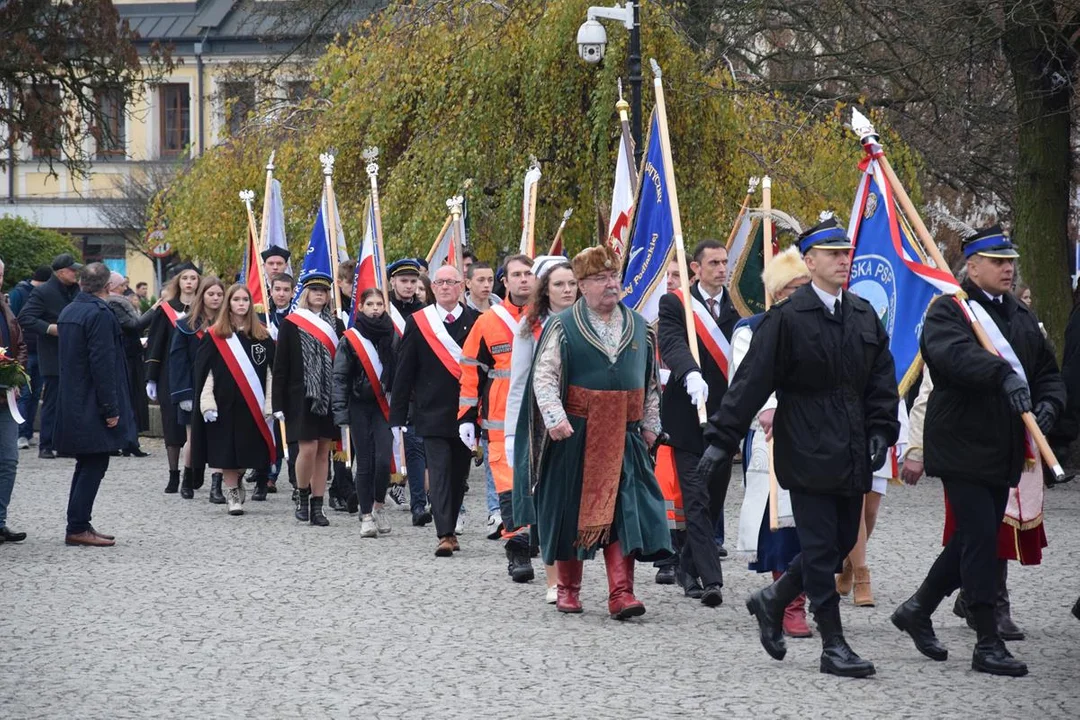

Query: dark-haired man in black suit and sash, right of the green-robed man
left=658, top=240, right=739, bottom=608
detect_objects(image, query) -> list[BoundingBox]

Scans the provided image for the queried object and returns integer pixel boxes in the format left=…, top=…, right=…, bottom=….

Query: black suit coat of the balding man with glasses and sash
left=390, top=308, right=480, bottom=437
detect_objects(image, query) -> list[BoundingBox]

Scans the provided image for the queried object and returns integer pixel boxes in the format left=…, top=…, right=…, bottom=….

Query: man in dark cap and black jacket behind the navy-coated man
left=18, top=253, right=82, bottom=460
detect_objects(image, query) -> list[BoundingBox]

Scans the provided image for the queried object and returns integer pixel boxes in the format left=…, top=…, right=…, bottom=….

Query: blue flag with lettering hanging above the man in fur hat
left=622, top=112, right=675, bottom=323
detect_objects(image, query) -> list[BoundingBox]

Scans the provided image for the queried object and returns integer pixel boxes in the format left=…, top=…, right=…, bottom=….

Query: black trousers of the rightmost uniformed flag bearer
left=927, top=478, right=1009, bottom=609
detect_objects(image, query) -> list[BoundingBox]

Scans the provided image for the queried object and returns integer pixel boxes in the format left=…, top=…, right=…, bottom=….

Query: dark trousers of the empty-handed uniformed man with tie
left=788, top=490, right=863, bottom=613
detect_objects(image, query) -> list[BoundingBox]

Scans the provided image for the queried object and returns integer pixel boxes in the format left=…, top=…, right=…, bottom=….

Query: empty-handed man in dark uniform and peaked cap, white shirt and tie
left=698, top=218, right=900, bottom=678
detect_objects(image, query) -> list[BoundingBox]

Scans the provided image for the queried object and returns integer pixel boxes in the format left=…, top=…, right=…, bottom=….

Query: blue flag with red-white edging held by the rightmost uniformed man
left=848, top=160, right=959, bottom=395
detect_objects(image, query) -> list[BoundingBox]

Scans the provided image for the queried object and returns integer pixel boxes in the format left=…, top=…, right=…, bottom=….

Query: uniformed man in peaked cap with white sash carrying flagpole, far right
left=892, top=226, right=1065, bottom=676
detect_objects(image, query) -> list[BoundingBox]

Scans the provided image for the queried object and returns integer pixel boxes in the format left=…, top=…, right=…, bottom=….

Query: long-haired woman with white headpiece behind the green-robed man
left=504, top=255, right=581, bottom=604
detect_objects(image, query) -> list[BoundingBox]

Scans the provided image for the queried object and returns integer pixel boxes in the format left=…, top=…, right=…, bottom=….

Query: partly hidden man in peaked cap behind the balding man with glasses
left=387, top=258, right=431, bottom=527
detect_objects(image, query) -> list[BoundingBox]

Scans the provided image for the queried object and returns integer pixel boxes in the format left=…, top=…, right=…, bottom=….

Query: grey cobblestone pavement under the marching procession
left=0, top=441, right=1080, bottom=719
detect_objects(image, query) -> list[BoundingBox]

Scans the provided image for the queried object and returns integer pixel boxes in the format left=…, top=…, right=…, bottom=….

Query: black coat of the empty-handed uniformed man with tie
left=705, top=284, right=900, bottom=495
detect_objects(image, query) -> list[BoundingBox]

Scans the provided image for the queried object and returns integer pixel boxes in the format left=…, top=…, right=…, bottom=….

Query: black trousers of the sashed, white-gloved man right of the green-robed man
left=674, top=448, right=731, bottom=585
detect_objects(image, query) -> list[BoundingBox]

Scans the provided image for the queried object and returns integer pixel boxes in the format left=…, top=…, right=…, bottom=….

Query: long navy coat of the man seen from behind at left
left=54, top=293, right=136, bottom=456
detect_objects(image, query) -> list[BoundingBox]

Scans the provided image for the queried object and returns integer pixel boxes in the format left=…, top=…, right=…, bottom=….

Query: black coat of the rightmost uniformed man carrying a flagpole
left=920, top=281, right=1065, bottom=487
